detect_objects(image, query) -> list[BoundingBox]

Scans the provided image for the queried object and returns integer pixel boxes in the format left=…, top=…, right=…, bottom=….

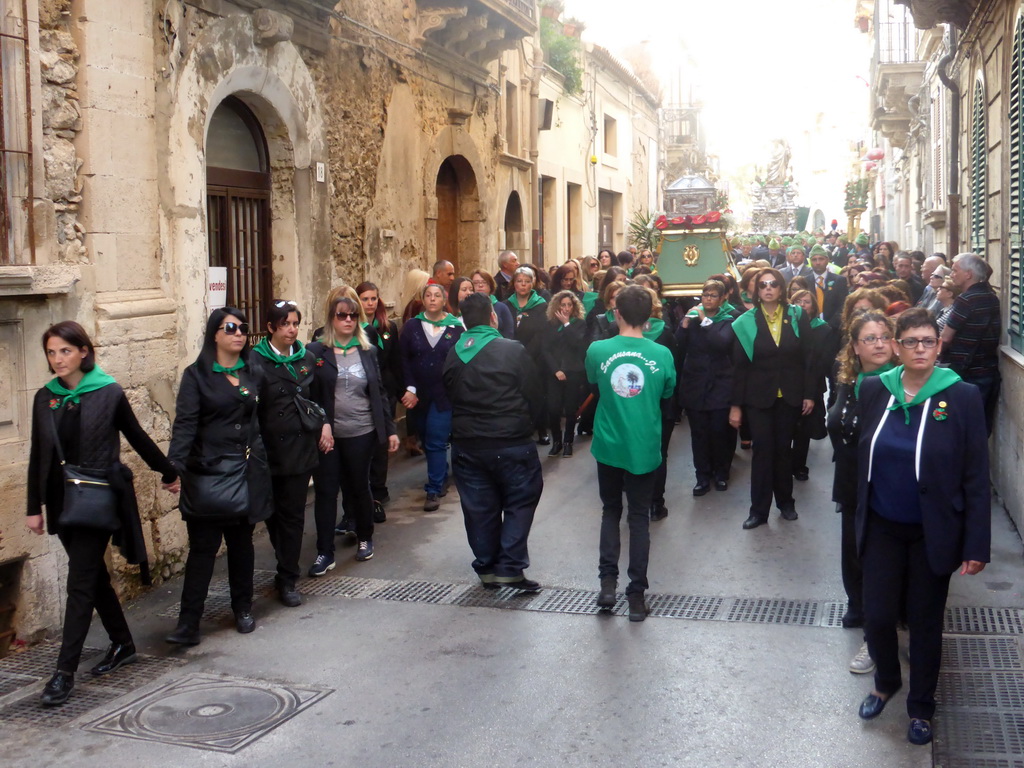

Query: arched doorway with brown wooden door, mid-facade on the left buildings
left=435, top=155, right=479, bottom=274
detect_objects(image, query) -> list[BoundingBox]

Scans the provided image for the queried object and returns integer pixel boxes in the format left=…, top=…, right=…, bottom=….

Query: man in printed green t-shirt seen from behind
left=587, top=286, right=676, bottom=622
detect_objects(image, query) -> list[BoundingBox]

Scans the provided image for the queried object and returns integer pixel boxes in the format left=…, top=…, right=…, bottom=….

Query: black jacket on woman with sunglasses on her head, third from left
left=249, top=349, right=319, bottom=475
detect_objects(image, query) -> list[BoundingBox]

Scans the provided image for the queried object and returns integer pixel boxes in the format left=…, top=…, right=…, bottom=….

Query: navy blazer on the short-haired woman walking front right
left=856, top=377, right=992, bottom=574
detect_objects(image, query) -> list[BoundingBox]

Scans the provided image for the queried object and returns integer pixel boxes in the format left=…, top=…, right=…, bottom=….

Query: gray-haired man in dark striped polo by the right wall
left=942, top=253, right=1000, bottom=434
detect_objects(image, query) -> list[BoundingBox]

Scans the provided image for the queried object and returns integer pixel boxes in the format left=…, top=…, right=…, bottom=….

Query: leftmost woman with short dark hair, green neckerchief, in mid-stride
left=26, top=321, right=178, bottom=707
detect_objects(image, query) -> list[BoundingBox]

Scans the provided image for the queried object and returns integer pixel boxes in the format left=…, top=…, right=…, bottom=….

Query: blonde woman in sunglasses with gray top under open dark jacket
left=309, top=296, right=398, bottom=577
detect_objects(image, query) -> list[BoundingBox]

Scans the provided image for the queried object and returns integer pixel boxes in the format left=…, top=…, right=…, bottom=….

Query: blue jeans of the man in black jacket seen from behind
left=452, top=442, right=544, bottom=582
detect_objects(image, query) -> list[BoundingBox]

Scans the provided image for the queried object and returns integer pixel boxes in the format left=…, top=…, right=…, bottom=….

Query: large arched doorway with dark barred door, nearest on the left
left=206, top=96, right=272, bottom=336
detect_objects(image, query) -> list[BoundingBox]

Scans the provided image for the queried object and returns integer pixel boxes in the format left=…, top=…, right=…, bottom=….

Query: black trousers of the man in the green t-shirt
left=597, top=462, right=654, bottom=595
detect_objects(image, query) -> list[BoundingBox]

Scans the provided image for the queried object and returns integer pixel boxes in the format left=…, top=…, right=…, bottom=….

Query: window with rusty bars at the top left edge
left=0, top=0, right=34, bottom=264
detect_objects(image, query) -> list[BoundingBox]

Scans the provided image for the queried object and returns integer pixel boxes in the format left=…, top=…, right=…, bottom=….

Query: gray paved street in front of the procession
left=0, top=424, right=1024, bottom=768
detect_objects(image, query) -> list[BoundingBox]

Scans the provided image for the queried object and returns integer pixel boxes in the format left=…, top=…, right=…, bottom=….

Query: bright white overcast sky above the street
left=564, top=0, right=870, bottom=217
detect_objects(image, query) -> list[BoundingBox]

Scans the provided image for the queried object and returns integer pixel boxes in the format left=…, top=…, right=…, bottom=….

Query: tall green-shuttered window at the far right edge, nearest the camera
left=1007, top=15, right=1024, bottom=352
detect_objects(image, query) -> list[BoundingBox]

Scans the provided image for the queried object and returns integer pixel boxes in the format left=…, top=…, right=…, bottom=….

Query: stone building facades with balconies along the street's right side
left=871, top=0, right=1024, bottom=528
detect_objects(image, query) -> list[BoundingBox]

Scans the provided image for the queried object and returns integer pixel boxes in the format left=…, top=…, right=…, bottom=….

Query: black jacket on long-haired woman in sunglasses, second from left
left=168, top=361, right=272, bottom=523
